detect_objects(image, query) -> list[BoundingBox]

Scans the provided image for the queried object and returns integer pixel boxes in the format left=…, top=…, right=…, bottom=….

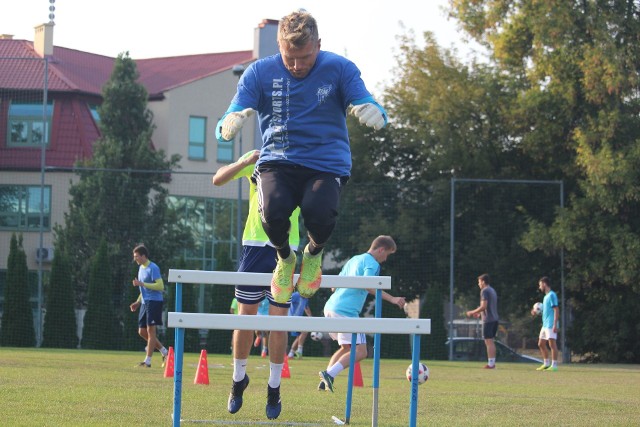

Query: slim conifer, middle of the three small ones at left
left=42, top=247, right=78, bottom=348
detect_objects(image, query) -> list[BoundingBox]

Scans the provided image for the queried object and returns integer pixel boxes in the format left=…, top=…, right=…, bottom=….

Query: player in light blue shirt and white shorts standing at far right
left=531, top=276, right=560, bottom=372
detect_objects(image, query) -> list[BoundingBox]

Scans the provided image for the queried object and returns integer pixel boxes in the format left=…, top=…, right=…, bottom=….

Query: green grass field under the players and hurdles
left=0, top=348, right=640, bottom=427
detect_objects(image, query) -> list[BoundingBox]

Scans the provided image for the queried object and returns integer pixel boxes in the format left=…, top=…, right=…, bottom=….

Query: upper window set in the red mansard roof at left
left=8, top=102, right=53, bottom=147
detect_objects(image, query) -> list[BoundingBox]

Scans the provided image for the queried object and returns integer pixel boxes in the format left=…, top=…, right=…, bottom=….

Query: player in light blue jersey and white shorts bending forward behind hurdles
left=318, top=236, right=406, bottom=392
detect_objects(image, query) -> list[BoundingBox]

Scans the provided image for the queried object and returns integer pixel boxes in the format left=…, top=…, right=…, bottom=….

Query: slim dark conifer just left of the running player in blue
left=82, top=240, right=122, bottom=350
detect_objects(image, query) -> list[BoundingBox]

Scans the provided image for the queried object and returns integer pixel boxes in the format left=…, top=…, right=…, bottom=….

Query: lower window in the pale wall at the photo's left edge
left=0, top=185, right=51, bottom=231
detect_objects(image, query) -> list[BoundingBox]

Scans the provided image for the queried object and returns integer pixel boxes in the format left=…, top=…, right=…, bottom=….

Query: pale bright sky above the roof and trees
left=0, top=0, right=480, bottom=93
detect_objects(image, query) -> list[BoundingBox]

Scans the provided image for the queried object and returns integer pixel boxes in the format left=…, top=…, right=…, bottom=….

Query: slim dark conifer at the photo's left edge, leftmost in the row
left=0, top=234, right=36, bottom=347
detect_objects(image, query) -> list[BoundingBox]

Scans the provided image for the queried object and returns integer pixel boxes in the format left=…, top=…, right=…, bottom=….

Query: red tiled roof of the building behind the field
left=0, top=39, right=253, bottom=170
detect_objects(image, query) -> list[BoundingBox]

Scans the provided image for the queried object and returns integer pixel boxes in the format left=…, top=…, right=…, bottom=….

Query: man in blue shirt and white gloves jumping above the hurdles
left=216, top=11, right=387, bottom=314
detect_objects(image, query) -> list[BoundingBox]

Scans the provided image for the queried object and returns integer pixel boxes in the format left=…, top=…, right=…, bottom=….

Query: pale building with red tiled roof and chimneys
left=0, top=20, right=277, bottom=270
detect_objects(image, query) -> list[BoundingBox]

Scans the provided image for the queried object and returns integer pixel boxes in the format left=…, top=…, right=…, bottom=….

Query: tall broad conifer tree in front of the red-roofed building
left=56, top=53, right=191, bottom=334
